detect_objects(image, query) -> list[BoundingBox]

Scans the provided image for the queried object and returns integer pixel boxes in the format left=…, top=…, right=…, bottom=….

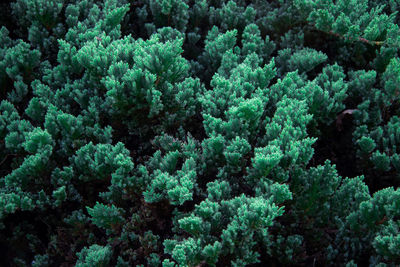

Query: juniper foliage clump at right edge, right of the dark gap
left=354, top=58, right=400, bottom=180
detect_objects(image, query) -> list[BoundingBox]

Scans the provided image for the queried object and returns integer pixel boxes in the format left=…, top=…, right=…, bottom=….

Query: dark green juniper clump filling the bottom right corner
left=334, top=187, right=400, bottom=264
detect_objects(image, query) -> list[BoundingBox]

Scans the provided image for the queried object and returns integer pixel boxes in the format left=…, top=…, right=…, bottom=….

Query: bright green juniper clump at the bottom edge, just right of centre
left=164, top=194, right=283, bottom=266
